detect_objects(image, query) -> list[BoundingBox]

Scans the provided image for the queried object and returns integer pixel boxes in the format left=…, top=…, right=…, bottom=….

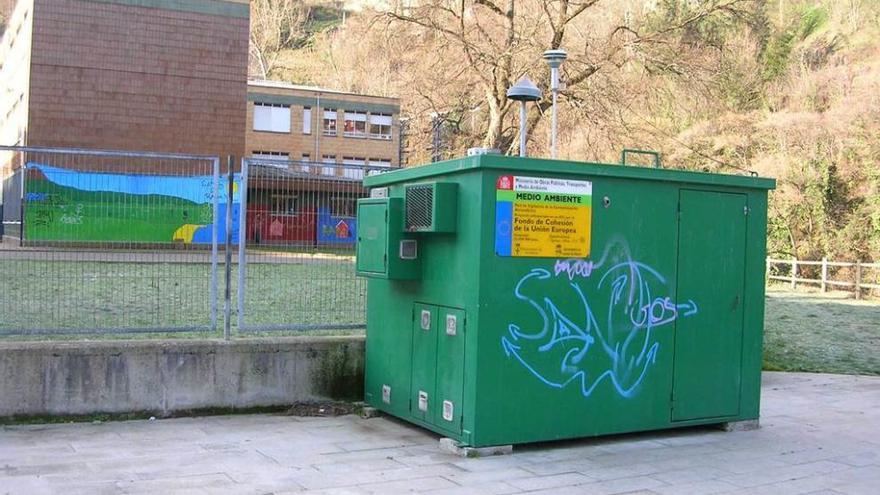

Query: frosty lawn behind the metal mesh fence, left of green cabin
left=0, top=259, right=366, bottom=337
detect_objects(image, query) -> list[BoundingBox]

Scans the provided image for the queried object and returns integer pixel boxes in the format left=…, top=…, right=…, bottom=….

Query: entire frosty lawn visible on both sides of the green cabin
left=0, top=257, right=880, bottom=375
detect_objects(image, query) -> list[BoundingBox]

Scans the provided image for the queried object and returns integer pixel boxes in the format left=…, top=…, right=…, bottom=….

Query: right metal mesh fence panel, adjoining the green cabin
left=236, top=158, right=388, bottom=332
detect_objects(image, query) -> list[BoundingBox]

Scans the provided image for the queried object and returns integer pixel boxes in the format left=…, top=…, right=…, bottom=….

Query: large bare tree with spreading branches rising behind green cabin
left=384, top=0, right=752, bottom=150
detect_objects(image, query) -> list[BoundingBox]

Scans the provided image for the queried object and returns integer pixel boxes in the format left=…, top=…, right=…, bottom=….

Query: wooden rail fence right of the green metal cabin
left=767, top=258, right=880, bottom=299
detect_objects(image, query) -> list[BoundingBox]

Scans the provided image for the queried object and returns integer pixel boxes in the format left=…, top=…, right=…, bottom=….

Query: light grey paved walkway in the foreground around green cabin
left=0, top=373, right=880, bottom=495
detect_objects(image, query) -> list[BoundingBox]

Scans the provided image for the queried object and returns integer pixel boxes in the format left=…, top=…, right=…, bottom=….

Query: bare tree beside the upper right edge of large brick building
left=250, top=0, right=311, bottom=79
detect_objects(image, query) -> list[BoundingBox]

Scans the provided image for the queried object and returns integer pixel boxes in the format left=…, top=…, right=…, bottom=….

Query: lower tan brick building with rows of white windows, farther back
left=246, top=81, right=400, bottom=245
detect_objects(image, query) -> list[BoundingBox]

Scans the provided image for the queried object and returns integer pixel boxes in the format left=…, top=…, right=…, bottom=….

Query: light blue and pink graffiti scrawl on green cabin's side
left=501, top=241, right=699, bottom=397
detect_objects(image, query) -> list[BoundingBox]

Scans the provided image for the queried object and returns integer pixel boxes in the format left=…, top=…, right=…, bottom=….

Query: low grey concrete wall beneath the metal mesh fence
left=0, top=336, right=364, bottom=418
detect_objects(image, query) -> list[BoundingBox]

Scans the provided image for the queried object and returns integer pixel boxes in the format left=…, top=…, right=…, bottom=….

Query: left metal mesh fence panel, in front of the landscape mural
left=0, top=147, right=220, bottom=336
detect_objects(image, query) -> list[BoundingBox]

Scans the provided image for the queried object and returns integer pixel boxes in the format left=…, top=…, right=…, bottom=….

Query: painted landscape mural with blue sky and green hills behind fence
left=25, top=163, right=240, bottom=244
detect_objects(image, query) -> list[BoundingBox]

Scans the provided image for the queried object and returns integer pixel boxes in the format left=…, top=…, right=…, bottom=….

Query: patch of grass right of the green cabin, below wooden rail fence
left=764, top=290, right=880, bottom=375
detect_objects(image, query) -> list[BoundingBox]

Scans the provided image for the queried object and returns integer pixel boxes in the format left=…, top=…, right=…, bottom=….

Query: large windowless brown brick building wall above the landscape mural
left=0, top=0, right=250, bottom=161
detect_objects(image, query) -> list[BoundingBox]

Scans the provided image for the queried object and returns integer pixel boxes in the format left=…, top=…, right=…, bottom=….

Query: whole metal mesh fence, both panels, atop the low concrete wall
left=0, top=146, right=389, bottom=338
